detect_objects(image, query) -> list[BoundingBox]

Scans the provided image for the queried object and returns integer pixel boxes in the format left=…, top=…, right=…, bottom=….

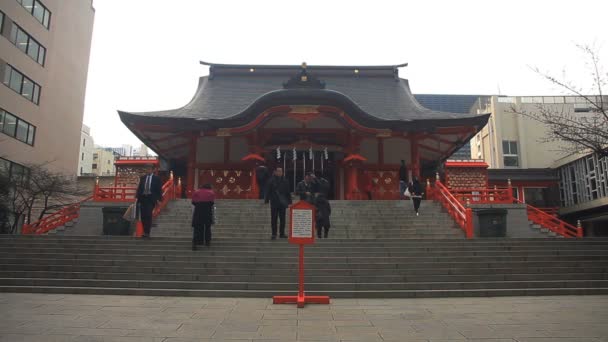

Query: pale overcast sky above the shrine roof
left=84, top=0, right=608, bottom=146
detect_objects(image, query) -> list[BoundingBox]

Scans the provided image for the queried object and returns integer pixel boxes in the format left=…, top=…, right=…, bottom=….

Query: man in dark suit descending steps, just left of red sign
left=264, top=167, right=291, bottom=240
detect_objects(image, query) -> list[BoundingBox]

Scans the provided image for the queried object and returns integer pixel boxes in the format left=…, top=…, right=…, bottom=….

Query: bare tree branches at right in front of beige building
left=510, top=45, right=608, bottom=156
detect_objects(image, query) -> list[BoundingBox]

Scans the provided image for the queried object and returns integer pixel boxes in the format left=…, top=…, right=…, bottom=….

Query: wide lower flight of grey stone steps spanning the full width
left=0, top=235, right=608, bottom=298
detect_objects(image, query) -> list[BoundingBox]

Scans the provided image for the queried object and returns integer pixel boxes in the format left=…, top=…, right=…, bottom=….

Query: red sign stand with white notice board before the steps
left=272, top=201, right=329, bottom=308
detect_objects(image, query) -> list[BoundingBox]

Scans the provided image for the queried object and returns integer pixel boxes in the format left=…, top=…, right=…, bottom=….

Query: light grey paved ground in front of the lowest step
left=0, top=293, right=608, bottom=342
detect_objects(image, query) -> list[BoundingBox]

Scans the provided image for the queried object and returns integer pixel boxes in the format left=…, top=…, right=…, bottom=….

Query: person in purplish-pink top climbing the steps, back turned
left=192, top=184, right=215, bottom=251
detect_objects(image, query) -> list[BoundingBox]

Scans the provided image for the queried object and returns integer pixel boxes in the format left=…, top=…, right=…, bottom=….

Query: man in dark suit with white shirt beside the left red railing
left=136, top=168, right=163, bottom=237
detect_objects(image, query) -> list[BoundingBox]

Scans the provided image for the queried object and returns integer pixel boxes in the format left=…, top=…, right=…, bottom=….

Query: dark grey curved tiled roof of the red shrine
left=121, top=65, right=487, bottom=126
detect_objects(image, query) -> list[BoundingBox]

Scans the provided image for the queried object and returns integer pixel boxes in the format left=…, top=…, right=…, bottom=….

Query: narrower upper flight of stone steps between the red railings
left=152, top=200, right=464, bottom=239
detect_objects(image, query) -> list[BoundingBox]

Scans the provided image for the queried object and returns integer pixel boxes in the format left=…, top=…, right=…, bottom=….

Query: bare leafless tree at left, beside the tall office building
left=0, top=164, right=90, bottom=233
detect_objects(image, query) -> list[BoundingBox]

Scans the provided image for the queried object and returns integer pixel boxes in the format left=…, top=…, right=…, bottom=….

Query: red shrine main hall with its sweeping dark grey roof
left=119, top=62, right=489, bottom=199
